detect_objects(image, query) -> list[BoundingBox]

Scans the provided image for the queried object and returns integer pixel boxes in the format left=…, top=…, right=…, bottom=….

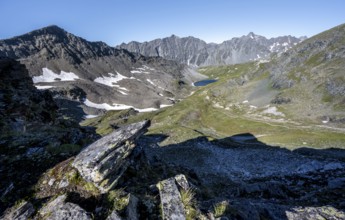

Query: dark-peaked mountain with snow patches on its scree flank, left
left=0, top=26, right=201, bottom=117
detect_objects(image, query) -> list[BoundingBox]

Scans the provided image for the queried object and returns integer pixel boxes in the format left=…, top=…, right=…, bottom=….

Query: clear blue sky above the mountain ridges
left=0, top=0, right=345, bottom=46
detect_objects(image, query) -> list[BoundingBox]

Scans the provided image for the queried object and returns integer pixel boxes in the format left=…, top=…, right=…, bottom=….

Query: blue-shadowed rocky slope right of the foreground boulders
left=135, top=133, right=345, bottom=219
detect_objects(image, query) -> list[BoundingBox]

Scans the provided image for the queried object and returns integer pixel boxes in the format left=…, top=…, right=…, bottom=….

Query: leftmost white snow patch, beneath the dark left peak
left=32, top=68, right=79, bottom=83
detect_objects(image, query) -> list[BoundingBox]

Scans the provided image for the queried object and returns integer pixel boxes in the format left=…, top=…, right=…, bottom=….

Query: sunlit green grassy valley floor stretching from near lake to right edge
left=84, top=63, right=345, bottom=149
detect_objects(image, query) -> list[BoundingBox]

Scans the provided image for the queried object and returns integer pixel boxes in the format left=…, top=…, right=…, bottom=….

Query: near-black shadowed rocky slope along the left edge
left=0, top=58, right=98, bottom=216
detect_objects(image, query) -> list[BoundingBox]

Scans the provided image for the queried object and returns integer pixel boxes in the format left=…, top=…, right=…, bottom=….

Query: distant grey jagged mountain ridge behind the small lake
left=117, top=32, right=305, bottom=66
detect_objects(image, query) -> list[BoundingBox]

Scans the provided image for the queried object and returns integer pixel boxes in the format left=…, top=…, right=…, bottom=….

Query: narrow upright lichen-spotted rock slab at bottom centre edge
left=158, top=178, right=186, bottom=220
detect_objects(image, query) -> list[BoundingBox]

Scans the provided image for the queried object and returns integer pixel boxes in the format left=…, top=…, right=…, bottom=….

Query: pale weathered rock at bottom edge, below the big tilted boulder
left=39, top=195, right=92, bottom=220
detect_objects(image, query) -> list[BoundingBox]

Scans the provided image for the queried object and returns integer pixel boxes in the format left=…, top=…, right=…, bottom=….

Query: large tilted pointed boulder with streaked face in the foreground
left=72, top=121, right=150, bottom=192
